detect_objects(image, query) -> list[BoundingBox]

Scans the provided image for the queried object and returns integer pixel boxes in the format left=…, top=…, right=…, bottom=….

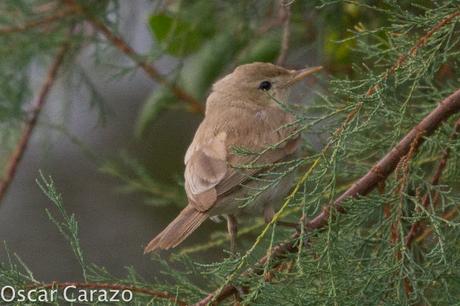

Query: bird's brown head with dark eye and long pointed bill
left=213, top=62, right=322, bottom=105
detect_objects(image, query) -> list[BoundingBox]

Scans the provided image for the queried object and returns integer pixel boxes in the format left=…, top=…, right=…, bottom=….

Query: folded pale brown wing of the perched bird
left=184, top=109, right=299, bottom=212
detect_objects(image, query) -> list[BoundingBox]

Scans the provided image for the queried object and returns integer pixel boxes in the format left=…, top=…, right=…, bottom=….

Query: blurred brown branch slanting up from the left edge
left=0, top=42, right=69, bottom=203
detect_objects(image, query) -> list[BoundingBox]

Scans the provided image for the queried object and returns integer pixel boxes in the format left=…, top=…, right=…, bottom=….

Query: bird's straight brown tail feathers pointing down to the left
left=144, top=205, right=208, bottom=254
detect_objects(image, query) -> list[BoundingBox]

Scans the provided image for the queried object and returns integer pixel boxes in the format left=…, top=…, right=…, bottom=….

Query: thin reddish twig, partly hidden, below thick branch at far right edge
left=405, top=119, right=460, bottom=248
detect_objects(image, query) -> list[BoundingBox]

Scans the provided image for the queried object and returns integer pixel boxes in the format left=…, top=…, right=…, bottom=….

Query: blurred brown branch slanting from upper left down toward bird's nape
left=63, top=0, right=204, bottom=114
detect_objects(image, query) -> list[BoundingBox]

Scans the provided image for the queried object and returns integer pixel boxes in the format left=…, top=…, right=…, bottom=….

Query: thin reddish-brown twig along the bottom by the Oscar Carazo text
left=28, top=282, right=187, bottom=306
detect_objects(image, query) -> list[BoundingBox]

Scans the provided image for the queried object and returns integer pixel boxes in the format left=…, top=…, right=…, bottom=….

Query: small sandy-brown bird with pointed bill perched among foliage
left=144, top=63, right=321, bottom=253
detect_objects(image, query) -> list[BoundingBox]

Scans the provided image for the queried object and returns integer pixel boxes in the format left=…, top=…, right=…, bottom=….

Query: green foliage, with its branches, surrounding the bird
left=0, top=0, right=460, bottom=305
